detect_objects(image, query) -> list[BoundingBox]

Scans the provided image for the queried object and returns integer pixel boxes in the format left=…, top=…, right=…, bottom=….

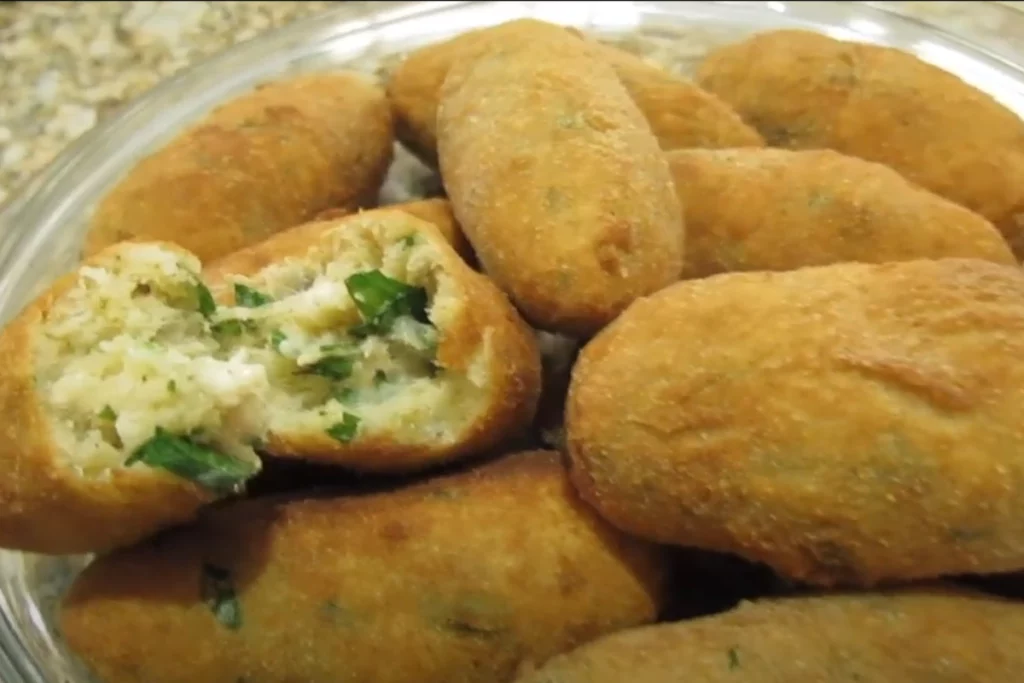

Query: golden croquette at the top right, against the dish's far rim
left=697, top=30, right=1024, bottom=256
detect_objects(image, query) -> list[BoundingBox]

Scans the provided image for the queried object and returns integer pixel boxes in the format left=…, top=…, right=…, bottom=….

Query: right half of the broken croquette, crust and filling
left=205, top=209, right=541, bottom=471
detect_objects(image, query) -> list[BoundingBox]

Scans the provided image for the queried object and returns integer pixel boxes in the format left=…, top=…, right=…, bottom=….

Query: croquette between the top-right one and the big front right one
left=667, top=150, right=1016, bottom=278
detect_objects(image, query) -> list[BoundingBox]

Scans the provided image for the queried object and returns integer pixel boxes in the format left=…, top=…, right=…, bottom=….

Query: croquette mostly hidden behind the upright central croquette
left=387, top=19, right=764, bottom=164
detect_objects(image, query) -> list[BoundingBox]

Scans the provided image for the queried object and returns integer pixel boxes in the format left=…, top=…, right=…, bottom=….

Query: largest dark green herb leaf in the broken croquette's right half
left=345, top=270, right=430, bottom=336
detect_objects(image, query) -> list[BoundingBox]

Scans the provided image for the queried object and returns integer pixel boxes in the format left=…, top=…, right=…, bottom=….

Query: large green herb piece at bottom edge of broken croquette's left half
left=125, top=427, right=256, bottom=495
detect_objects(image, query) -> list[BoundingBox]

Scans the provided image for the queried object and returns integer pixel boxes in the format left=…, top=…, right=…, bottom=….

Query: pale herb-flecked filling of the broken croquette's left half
left=37, top=245, right=268, bottom=488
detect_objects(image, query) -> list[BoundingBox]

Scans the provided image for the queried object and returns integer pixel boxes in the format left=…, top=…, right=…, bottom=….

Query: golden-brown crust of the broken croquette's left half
left=0, top=245, right=212, bottom=554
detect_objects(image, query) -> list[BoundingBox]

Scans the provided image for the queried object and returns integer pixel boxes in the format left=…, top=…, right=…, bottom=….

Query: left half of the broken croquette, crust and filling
left=0, top=243, right=267, bottom=554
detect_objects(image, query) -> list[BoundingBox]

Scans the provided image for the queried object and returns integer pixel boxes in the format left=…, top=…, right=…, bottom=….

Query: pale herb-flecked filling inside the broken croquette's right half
left=207, top=219, right=487, bottom=445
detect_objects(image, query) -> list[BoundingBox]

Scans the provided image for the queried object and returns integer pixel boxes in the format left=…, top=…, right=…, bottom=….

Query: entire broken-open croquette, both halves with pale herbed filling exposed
left=0, top=210, right=541, bottom=553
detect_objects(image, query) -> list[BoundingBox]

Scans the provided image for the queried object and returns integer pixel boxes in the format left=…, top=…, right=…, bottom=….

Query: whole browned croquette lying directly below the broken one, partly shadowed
left=60, top=453, right=666, bottom=683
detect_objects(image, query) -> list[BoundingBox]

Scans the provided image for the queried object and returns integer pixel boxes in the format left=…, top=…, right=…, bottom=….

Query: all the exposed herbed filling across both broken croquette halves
left=37, top=223, right=488, bottom=492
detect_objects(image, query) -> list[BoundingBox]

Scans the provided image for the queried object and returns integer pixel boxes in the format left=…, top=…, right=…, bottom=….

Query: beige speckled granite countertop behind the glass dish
left=0, top=1, right=1024, bottom=202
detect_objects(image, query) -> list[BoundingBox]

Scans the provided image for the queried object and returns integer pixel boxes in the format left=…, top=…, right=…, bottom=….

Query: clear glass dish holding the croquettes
left=0, top=2, right=1024, bottom=683
